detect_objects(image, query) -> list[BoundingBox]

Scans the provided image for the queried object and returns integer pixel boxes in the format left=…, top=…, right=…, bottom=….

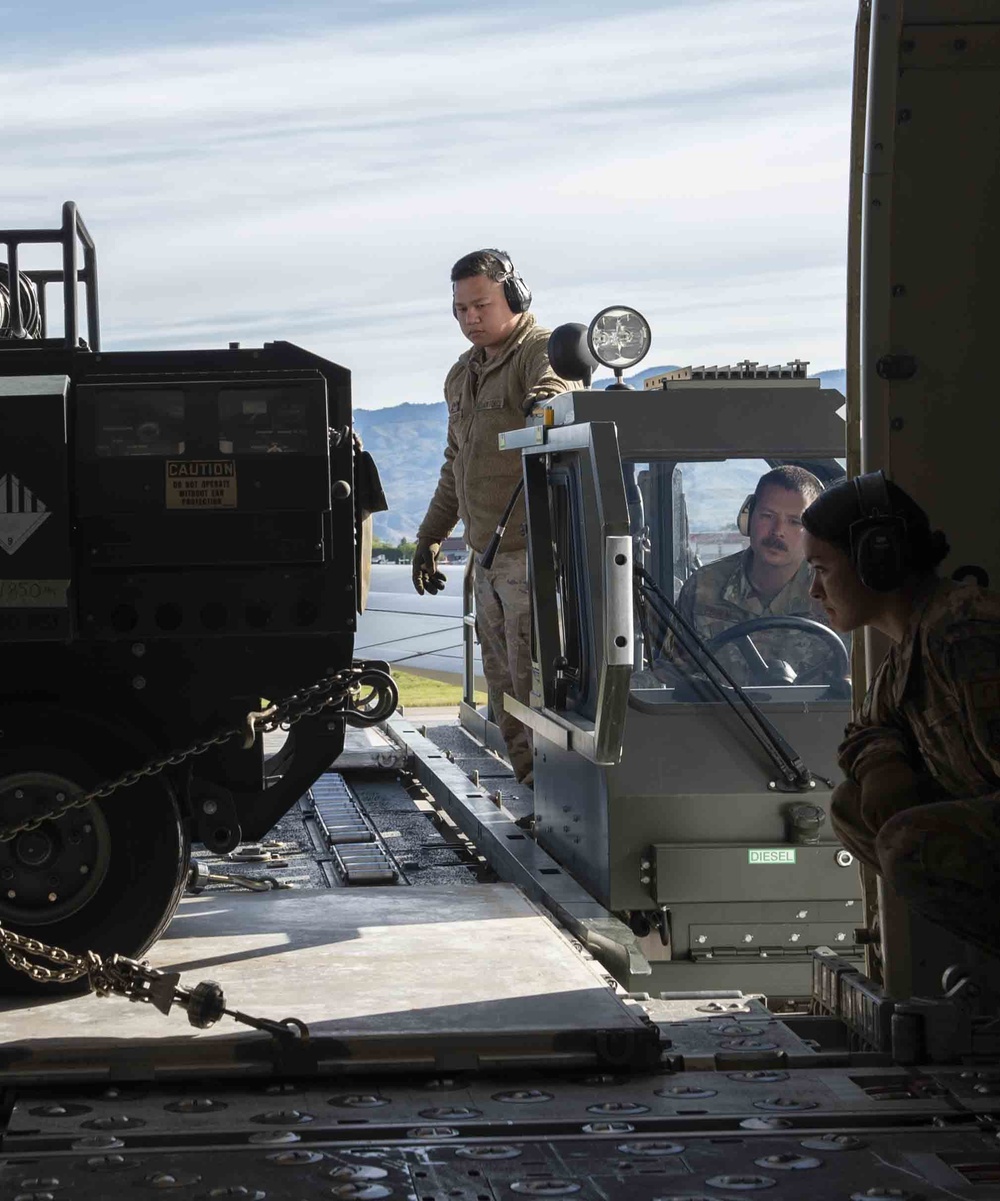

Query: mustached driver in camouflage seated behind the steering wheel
left=663, top=466, right=832, bottom=685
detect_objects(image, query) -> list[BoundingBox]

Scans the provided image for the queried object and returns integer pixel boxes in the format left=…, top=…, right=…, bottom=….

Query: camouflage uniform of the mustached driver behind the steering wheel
left=663, top=548, right=837, bottom=685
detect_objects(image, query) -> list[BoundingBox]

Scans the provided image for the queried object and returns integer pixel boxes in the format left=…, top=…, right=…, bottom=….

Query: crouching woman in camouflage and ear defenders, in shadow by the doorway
left=803, top=480, right=1000, bottom=955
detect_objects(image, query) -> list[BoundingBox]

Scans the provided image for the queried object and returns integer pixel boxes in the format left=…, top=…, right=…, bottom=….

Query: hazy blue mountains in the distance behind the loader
left=354, top=366, right=846, bottom=545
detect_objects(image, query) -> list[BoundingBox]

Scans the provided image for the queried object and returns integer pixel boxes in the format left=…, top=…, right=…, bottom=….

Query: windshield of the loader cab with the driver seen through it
left=623, top=459, right=850, bottom=703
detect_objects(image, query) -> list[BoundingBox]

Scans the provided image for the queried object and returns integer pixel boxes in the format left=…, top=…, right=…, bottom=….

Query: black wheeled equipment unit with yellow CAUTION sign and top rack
left=0, top=204, right=395, bottom=982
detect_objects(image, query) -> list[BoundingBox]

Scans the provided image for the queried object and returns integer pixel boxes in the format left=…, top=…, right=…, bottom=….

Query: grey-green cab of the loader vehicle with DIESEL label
left=502, top=350, right=864, bottom=998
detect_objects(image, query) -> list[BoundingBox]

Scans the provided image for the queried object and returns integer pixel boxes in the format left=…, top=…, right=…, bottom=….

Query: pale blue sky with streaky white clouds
left=0, top=0, right=856, bottom=407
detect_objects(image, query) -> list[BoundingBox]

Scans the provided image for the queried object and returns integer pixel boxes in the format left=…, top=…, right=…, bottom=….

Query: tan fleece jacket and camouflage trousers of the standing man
left=417, top=313, right=581, bottom=779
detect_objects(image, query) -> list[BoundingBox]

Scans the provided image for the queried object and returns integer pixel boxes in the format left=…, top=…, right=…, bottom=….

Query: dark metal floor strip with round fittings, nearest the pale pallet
left=6, top=1068, right=969, bottom=1133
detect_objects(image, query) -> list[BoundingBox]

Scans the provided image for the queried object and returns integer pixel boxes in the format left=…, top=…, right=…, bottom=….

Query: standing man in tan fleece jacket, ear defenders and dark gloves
left=413, top=250, right=580, bottom=784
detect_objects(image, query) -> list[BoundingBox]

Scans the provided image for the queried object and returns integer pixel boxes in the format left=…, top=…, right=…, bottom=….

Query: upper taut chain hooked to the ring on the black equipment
left=0, top=667, right=366, bottom=842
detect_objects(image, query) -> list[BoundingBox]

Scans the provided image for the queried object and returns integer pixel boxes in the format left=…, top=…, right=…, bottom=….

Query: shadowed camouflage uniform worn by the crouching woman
left=832, top=578, right=1000, bottom=954
